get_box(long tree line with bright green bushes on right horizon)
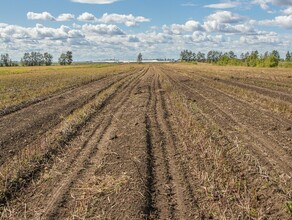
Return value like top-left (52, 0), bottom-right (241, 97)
top-left (180, 50), bottom-right (292, 67)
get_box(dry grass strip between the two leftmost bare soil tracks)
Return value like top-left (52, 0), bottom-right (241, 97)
top-left (0, 74), bottom-right (128, 206)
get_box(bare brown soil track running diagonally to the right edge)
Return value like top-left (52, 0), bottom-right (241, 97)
top-left (161, 66), bottom-right (292, 178)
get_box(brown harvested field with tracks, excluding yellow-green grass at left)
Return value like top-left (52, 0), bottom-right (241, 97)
top-left (0, 64), bottom-right (292, 219)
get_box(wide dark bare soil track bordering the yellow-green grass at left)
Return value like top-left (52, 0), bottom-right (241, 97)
top-left (0, 68), bottom-right (141, 165)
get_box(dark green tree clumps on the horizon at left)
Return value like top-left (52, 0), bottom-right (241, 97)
top-left (0, 51), bottom-right (73, 67)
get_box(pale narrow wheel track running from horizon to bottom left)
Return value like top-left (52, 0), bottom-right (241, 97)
top-left (40, 68), bottom-right (146, 219)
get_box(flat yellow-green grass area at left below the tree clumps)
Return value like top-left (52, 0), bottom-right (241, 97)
top-left (0, 65), bottom-right (135, 110)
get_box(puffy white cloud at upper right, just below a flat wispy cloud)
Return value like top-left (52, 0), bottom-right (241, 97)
top-left (206, 11), bottom-right (244, 24)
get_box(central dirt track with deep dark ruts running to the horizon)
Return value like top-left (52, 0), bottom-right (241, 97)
top-left (145, 68), bottom-right (196, 219)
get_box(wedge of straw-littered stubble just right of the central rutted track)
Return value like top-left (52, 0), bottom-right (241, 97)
top-left (164, 72), bottom-right (291, 219)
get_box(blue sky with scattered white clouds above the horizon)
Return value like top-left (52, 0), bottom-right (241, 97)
top-left (0, 0), bottom-right (292, 61)
